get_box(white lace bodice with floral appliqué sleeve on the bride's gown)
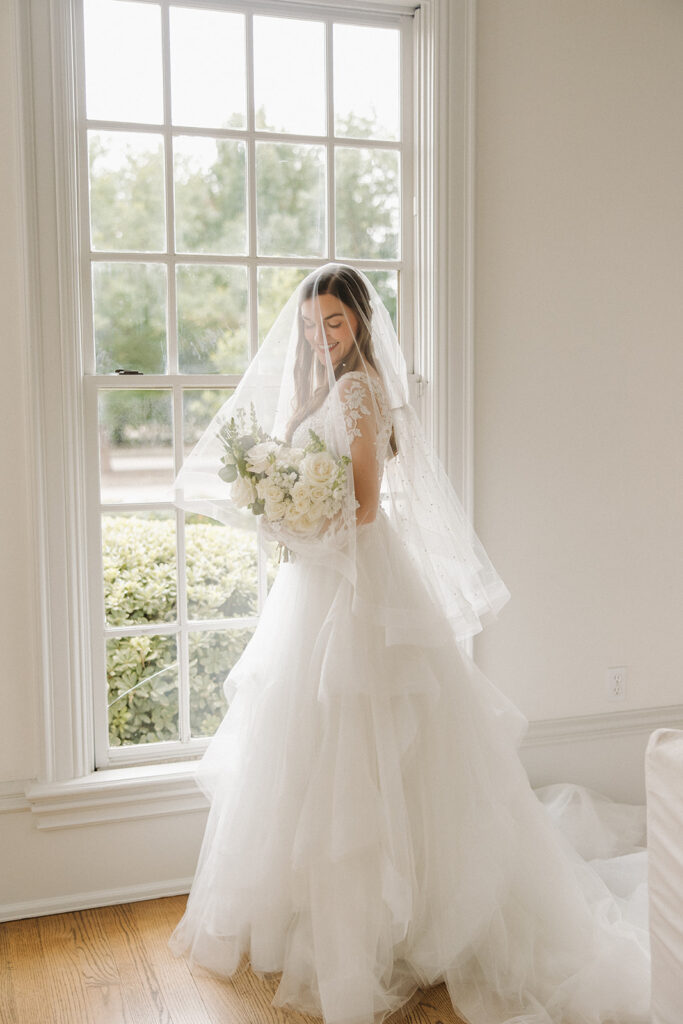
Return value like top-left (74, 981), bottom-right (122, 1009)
top-left (292, 370), bottom-right (391, 476)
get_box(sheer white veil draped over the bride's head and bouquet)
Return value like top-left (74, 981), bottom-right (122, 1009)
top-left (170, 263), bottom-right (510, 642)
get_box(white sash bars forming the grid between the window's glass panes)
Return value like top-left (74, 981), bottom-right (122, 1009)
top-left (74, 0), bottom-right (415, 769)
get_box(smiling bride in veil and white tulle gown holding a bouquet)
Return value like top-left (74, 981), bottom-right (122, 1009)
top-left (165, 263), bottom-right (649, 1024)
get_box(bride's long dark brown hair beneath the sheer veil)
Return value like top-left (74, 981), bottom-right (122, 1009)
top-left (286, 264), bottom-right (397, 455)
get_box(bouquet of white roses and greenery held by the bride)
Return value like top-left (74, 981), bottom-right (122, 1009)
top-left (218, 406), bottom-right (351, 537)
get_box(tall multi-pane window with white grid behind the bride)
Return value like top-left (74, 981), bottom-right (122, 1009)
top-left (79, 0), bottom-right (413, 767)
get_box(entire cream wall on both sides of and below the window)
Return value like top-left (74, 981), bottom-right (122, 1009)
top-left (0, 0), bottom-right (683, 915)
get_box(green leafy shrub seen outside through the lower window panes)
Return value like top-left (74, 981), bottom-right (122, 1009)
top-left (102, 513), bottom-right (264, 746)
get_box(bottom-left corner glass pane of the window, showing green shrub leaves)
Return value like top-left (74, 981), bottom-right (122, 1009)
top-left (106, 636), bottom-right (178, 746)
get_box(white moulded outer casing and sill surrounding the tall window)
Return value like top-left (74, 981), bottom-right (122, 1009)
top-left (13, 0), bottom-right (475, 828)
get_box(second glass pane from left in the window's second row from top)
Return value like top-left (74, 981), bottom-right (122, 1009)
top-left (173, 135), bottom-right (247, 255)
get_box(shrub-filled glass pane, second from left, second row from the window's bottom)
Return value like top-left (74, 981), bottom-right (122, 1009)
top-left (185, 514), bottom-right (258, 621)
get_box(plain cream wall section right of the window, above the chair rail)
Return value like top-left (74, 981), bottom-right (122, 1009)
top-left (475, 0), bottom-right (683, 720)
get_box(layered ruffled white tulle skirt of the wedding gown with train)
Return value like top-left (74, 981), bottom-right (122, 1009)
top-left (170, 514), bottom-right (649, 1024)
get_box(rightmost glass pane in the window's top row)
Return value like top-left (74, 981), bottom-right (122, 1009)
top-left (334, 25), bottom-right (400, 139)
